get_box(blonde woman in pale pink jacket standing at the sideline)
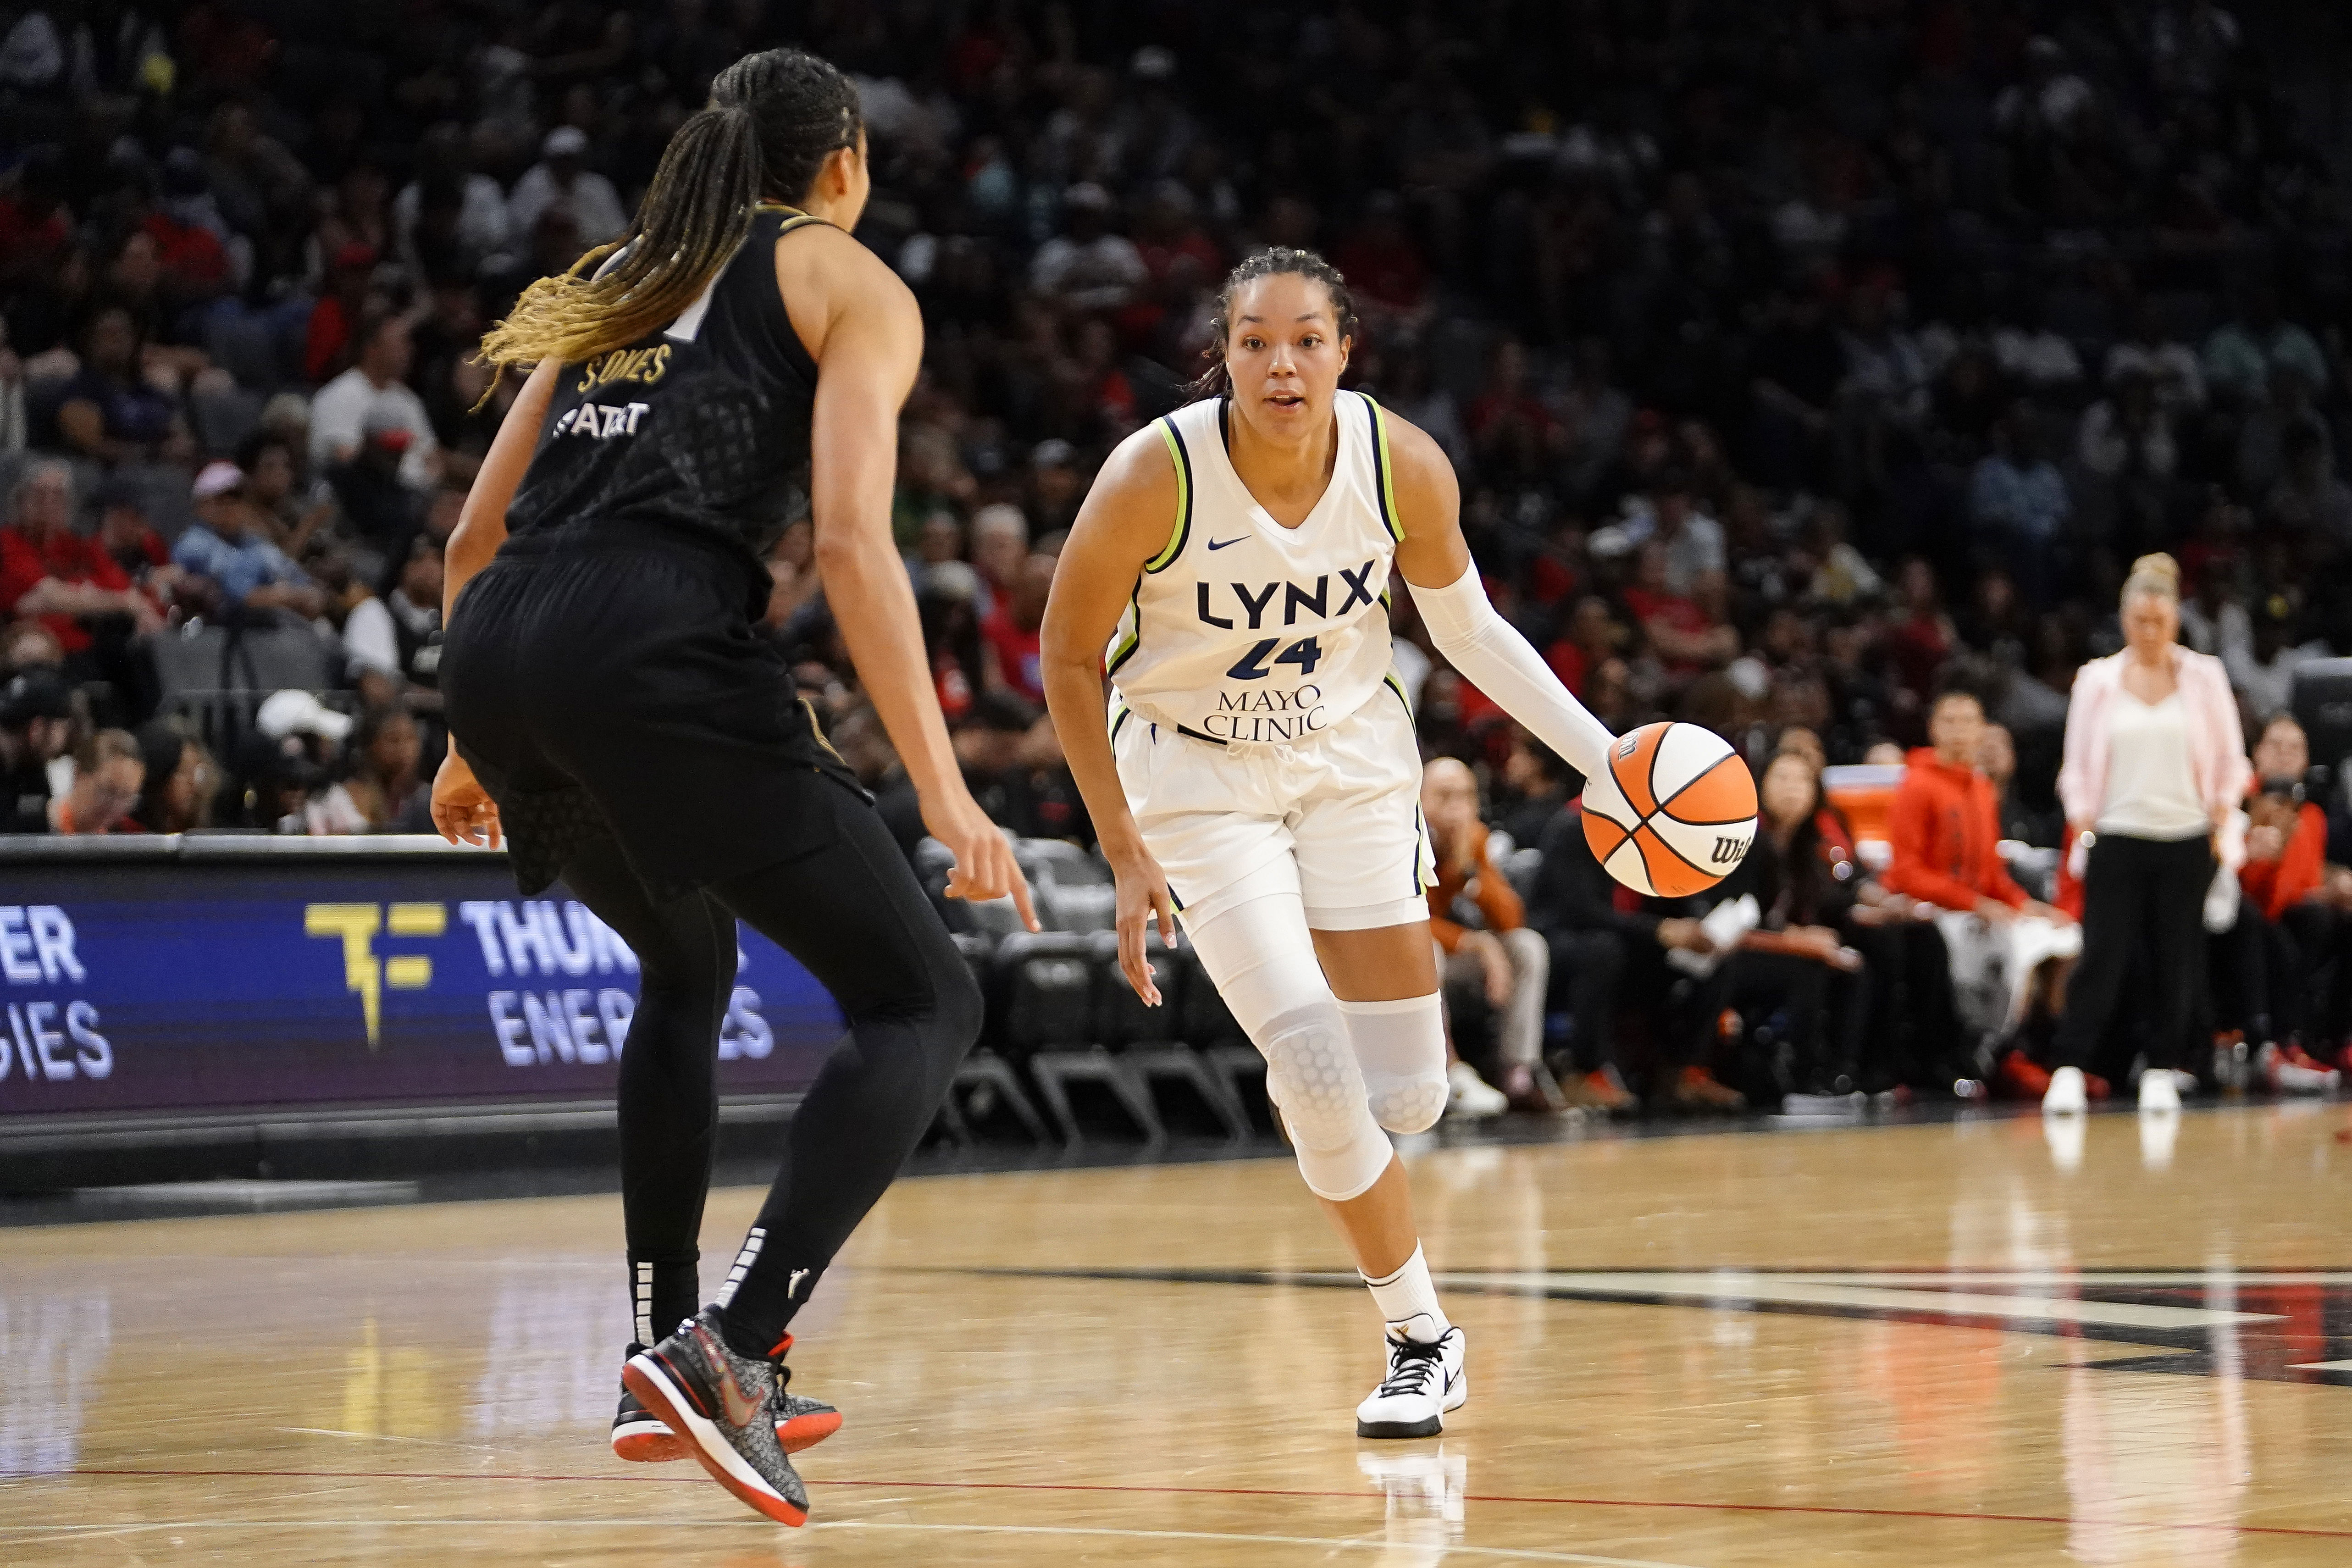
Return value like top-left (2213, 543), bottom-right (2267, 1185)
top-left (2042, 555), bottom-right (2251, 1112)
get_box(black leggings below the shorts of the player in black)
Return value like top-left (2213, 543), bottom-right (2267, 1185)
top-left (564, 787), bottom-right (981, 1357)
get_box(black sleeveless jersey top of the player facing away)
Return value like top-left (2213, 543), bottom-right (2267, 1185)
top-left (506, 202), bottom-right (823, 583)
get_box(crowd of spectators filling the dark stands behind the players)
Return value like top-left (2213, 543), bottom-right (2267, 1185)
top-left (0, 0), bottom-right (2352, 1105)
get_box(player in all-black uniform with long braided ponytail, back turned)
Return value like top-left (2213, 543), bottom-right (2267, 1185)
top-left (433, 50), bottom-right (1035, 1526)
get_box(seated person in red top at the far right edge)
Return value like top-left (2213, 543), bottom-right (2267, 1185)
top-left (2213, 712), bottom-right (2352, 1088)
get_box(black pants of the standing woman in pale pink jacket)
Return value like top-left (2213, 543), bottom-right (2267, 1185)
top-left (2056, 832), bottom-right (2213, 1067)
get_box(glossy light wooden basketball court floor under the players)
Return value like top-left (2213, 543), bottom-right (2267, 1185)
top-left (0, 1107), bottom-right (2352, 1568)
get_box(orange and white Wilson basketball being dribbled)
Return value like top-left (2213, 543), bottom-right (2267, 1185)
top-left (1585, 724), bottom-right (1757, 898)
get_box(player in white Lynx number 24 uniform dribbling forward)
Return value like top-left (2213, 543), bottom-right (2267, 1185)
top-left (1044, 249), bottom-right (1611, 1436)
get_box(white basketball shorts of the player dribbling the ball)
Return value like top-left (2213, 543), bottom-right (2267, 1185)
top-left (1110, 687), bottom-right (1437, 931)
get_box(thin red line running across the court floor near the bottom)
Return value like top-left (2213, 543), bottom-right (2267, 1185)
top-left (0, 1469), bottom-right (2352, 1540)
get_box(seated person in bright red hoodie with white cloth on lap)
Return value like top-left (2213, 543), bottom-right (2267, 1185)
top-left (1879, 689), bottom-right (2081, 1098)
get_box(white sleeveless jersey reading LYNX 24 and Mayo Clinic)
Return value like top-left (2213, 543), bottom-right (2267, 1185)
top-left (1106, 393), bottom-right (1404, 745)
